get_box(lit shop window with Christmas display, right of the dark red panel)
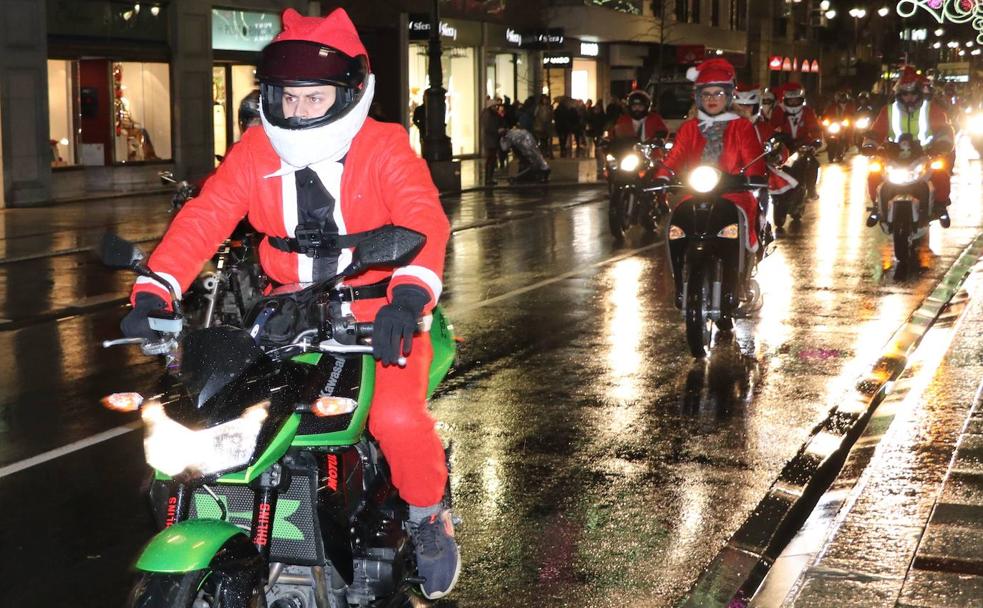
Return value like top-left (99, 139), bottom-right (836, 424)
top-left (112, 62), bottom-right (171, 163)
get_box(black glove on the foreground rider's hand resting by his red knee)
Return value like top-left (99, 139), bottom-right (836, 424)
top-left (372, 285), bottom-right (430, 365)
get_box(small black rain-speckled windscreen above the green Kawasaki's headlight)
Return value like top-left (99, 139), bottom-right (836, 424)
top-left (181, 327), bottom-right (266, 409)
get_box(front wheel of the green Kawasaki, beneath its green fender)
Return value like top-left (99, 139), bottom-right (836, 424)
top-left (126, 570), bottom-right (267, 608)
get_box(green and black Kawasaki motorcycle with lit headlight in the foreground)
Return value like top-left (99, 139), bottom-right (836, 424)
top-left (102, 226), bottom-right (455, 608)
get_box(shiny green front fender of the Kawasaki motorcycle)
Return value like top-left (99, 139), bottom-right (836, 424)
top-left (136, 519), bottom-right (261, 574)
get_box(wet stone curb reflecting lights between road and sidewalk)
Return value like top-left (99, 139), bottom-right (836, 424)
top-left (679, 233), bottom-right (983, 608)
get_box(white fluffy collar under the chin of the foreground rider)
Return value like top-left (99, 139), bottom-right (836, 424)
top-left (260, 74), bottom-right (375, 177)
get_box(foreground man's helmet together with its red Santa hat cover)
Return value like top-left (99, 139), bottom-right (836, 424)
top-left (256, 8), bottom-right (371, 129)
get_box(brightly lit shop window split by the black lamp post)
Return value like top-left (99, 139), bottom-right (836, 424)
top-left (409, 44), bottom-right (478, 155)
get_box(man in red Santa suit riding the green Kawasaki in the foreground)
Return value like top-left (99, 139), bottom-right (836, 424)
top-left (122, 9), bottom-right (460, 599)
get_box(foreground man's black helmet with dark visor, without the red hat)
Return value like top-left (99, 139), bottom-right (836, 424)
top-left (256, 40), bottom-right (369, 129)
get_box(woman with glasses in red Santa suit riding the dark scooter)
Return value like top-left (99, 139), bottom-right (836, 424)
top-left (656, 59), bottom-right (766, 251)
